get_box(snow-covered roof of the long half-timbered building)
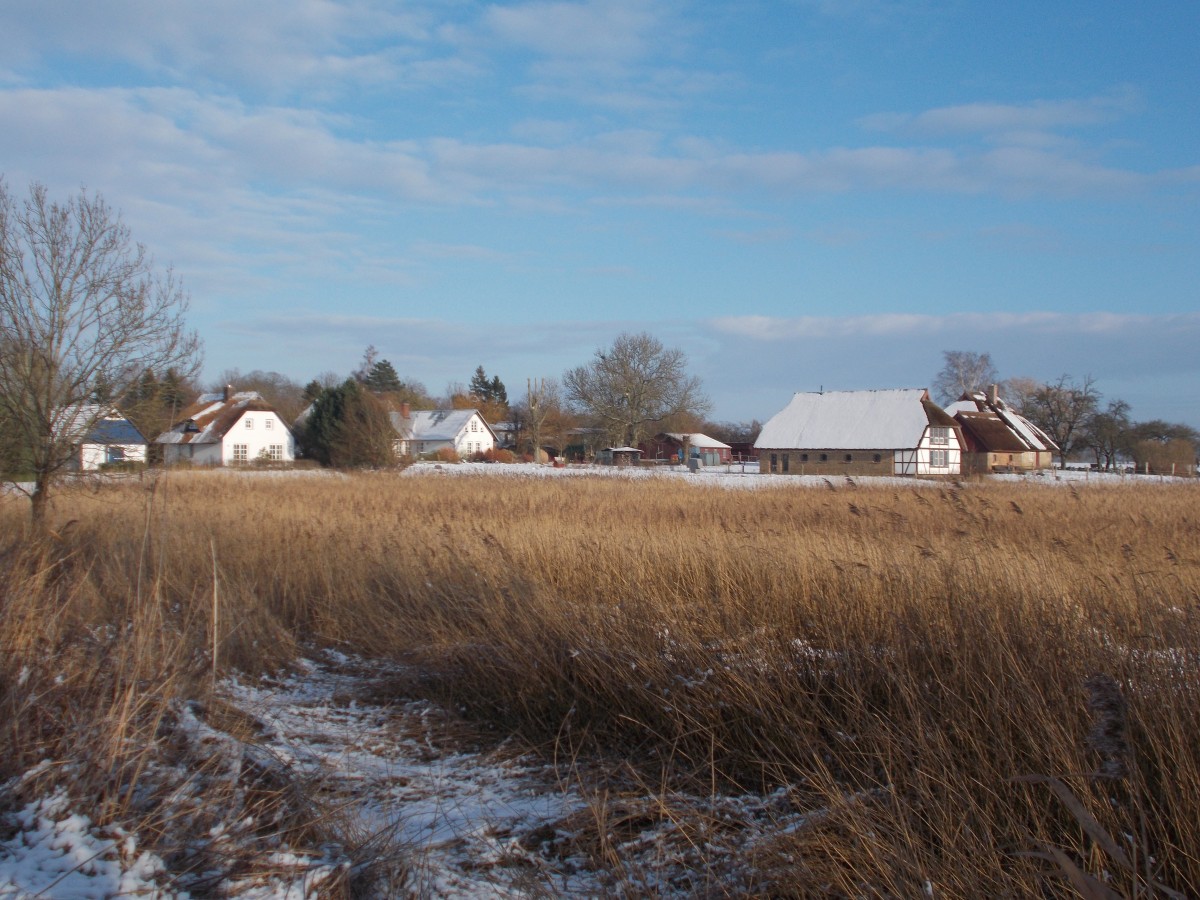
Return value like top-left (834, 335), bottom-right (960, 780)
top-left (755, 388), bottom-right (940, 450)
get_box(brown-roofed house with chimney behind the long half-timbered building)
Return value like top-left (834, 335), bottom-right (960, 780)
top-left (946, 384), bottom-right (1058, 473)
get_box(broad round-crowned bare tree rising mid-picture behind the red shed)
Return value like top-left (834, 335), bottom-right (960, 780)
top-left (563, 331), bottom-right (709, 446)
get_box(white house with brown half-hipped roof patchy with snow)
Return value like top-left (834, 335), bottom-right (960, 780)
top-left (155, 386), bottom-right (295, 466)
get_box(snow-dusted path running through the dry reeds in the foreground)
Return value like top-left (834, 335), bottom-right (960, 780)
top-left (228, 654), bottom-right (604, 898)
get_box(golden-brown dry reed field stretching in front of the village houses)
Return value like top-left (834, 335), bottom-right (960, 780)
top-left (0, 472), bottom-right (1200, 898)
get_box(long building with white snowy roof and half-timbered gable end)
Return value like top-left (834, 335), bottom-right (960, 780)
top-left (755, 388), bottom-right (962, 475)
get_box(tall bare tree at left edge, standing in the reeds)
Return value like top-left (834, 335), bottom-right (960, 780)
top-left (0, 179), bottom-right (199, 529)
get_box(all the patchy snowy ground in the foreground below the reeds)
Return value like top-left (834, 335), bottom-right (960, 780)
top-left (0, 653), bottom-right (820, 900)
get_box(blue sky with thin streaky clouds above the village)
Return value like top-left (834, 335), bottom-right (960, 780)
top-left (0, 0), bottom-right (1200, 426)
